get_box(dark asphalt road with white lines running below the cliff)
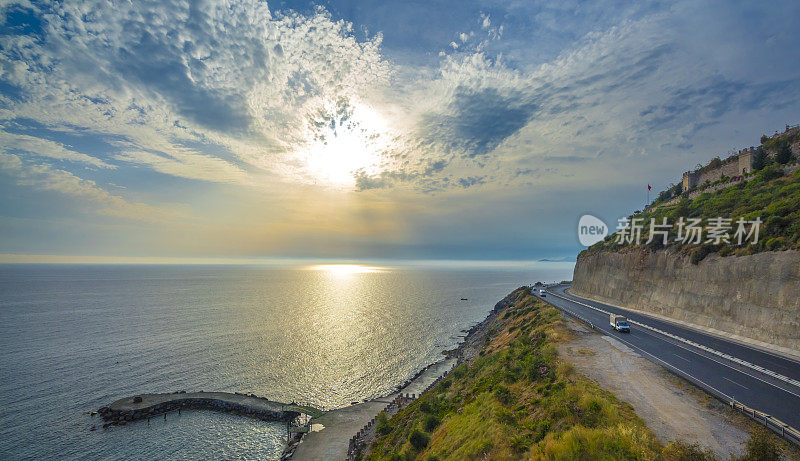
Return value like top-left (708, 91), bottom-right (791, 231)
top-left (537, 286), bottom-right (800, 429)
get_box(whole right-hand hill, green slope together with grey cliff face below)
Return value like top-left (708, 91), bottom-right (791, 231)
top-left (571, 127), bottom-right (800, 355)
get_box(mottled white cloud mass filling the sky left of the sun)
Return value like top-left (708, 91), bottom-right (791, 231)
top-left (0, 0), bottom-right (391, 184)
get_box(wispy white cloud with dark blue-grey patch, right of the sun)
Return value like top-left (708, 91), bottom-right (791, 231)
top-left (360, 3), bottom-right (800, 190)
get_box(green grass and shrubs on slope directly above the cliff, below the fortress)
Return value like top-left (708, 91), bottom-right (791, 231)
top-left (578, 165), bottom-right (800, 264)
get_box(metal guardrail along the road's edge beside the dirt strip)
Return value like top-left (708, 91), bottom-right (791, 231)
top-left (548, 292), bottom-right (800, 445)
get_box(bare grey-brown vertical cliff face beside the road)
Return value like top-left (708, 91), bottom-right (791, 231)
top-left (571, 250), bottom-right (800, 351)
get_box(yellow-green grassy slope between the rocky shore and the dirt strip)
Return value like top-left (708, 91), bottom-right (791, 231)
top-left (362, 288), bottom-right (780, 460)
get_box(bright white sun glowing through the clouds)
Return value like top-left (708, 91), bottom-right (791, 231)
top-left (304, 104), bottom-right (387, 186)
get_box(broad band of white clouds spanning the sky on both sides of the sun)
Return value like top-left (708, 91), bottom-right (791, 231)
top-left (0, 0), bottom-right (797, 198)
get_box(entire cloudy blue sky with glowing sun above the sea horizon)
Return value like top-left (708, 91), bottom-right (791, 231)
top-left (0, 0), bottom-right (800, 261)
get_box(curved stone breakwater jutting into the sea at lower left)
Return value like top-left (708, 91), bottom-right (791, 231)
top-left (97, 392), bottom-right (300, 428)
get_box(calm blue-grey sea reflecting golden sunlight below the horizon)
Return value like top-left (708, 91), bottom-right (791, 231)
top-left (0, 263), bottom-right (572, 459)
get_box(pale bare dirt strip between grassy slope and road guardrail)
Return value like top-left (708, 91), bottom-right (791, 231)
top-left (559, 320), bottom-right (749, 459)
